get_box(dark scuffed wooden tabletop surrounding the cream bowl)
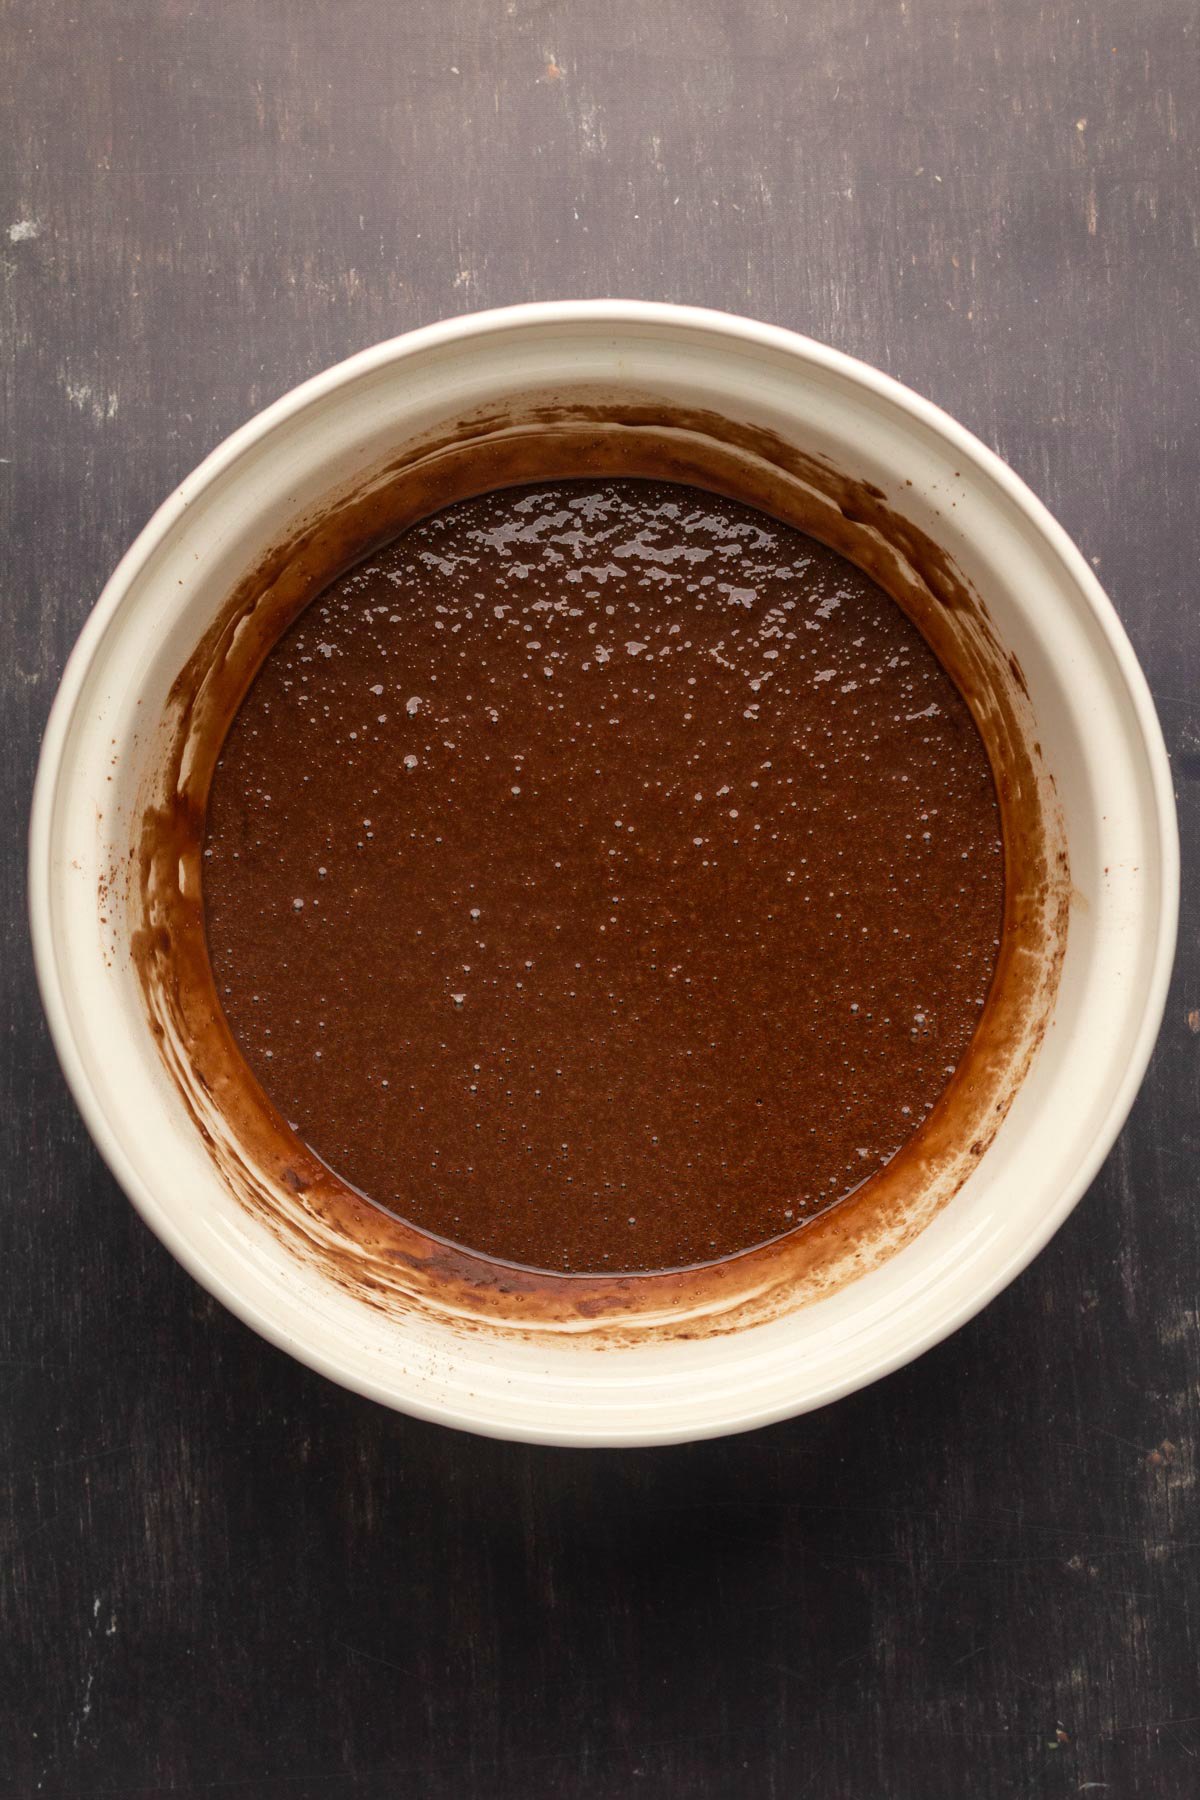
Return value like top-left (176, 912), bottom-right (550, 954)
top-left (0, 0), bottom-right (1200, 1800)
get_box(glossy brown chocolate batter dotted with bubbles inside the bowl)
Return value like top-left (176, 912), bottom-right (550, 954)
top-left (203, 481), bottom-right (1004, 1273)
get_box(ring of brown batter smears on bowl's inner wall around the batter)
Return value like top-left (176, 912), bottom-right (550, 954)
top-left (130, 394), bottom-right (1070, 1345)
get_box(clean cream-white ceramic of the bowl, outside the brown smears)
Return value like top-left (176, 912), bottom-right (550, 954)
top-left (31, 301), bottom-right (1178, 1444)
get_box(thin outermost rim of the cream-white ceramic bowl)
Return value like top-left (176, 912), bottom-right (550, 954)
top-left (29, 299), bottom-right (1180, 1445)
